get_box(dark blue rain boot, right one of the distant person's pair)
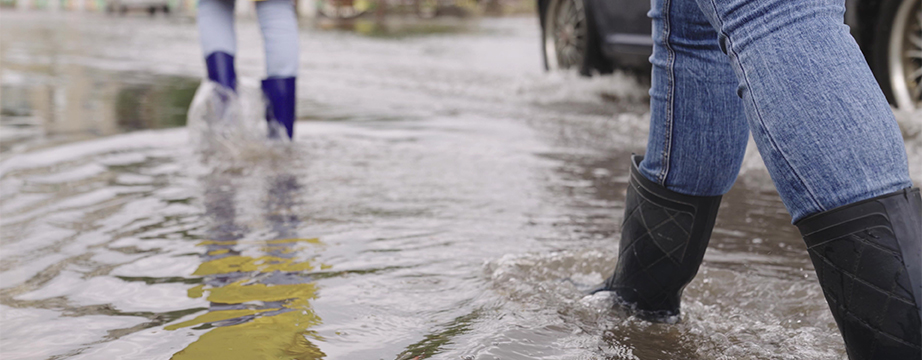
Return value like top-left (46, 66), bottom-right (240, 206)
top-left (262, 76), bottom-right (297, 139)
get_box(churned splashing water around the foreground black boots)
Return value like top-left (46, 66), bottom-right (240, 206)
top-left (484, 251), bottom-right (844, 360)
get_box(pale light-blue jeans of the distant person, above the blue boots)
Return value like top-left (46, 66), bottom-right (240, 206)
top-left (198, 0), bottom-right (298, 78)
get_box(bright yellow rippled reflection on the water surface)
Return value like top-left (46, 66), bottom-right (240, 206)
top-left (165, 239), bottom-right (329, 360)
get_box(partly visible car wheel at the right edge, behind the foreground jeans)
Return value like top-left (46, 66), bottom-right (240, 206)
top-left (873, 0), bottom-right (922, 111)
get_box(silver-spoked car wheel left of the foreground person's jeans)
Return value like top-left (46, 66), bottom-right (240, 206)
top-left (542, 0), bottom-right (612, 75)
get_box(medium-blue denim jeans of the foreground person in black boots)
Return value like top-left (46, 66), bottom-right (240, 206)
top-left (640, 0), bottom-right (912, 222)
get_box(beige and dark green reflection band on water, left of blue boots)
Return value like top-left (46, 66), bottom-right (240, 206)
top-left (0, 58), bottom-right (199, 152)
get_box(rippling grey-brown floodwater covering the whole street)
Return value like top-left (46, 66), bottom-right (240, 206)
top-left (0, 11), bottom-right (922, 360)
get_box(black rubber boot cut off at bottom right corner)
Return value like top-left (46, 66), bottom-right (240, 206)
top-left (796, 189), bottom-right (922, 360)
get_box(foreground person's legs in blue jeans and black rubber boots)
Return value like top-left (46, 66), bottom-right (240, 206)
top-left (604, 0), bottom-right (922, 359)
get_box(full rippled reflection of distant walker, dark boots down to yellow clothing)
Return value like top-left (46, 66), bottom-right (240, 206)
top-left (166, 174), bottom-right (325, 360)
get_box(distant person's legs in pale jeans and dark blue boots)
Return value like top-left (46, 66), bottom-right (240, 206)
top-left (198, 0), bottom-right (299, 137)
